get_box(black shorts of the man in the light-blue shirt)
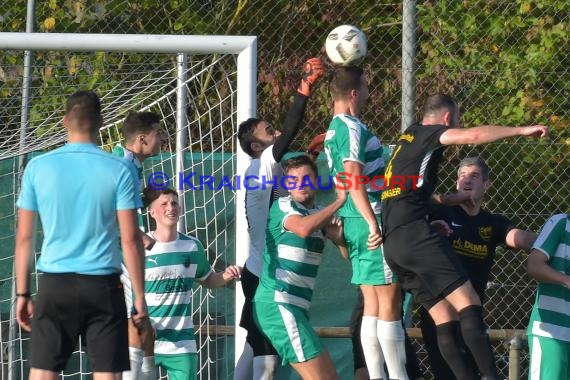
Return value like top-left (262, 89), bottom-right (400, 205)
top-left (30, 273), bottom-right (130, 372)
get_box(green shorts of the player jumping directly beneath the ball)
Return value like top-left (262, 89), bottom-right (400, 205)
top-left (342, 215), bottom-right (396, 285)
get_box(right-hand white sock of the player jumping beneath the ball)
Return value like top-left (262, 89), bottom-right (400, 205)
top-left (377, 320), bottom-right (408, 380)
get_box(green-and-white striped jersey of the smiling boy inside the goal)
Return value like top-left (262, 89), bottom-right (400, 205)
top-left (144, 233), bottom-right (212, 355)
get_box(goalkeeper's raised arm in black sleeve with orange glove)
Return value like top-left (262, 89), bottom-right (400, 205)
top-left (273, 58), bottom-right (325, 162)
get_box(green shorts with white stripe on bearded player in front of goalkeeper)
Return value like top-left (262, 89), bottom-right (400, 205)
top-left (253, 302), bottom-right (323, 365)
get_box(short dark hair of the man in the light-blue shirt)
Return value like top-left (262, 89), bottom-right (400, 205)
top-left (65, 90), bottom-right (103, 132)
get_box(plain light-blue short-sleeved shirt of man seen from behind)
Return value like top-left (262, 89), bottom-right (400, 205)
top-left (17, 143), bottom-right (141, 275)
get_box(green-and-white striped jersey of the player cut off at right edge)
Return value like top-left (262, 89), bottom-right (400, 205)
top-left (527, 214), bottom-right (570, 342)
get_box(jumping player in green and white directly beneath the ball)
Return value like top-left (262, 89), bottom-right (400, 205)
top-left (325, 66), bottom-right (408, 380)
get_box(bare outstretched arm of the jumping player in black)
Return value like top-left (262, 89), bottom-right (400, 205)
top-left (439, 125), bottom-right (549, 145)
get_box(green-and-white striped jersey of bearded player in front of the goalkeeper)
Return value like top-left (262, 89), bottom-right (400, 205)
top-left (254, 196), bottom-right (325, 310)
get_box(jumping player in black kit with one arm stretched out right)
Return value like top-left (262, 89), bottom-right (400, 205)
top-left (382, 94), bottom-right (548, 380)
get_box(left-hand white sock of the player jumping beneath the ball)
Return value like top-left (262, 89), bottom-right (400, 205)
top-left (360, 315), bottom-right (387, 379)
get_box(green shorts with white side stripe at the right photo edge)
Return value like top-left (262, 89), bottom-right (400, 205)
top-left (528, 335), bottom-right (570, 380)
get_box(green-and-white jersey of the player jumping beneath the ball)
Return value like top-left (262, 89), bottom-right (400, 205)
top-left (324, 114), bottom-right (385, 217)
